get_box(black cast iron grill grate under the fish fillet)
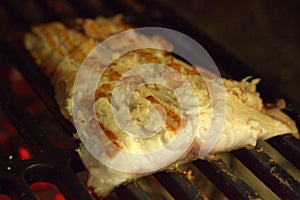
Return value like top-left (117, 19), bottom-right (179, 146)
top-left (0, 0), bottom-right (300, 199)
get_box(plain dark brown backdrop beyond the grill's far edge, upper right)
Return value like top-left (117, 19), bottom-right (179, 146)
top-left (160, 0), bottom-right (300, 105)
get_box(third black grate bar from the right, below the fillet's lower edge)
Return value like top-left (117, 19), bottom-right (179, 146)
top-left (193, 156), bottom-right (262, 199)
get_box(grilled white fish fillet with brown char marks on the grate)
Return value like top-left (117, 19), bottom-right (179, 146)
top-left (24, 15), bottom-right (299, 197)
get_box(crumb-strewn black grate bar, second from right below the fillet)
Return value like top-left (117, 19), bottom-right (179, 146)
top-left (233, 147), bottom-right (300, 199)
